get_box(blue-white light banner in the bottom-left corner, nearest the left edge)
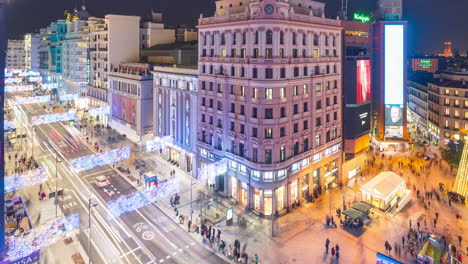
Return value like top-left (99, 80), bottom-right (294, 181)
top-left (6, 214), bottom-right (80, 263)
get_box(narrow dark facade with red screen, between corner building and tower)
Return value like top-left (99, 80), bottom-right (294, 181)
top-left (342, 19), bottom-right (372, 185)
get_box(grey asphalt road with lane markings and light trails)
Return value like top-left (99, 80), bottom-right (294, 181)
top-left (11, 99), bottom-right (227, 264)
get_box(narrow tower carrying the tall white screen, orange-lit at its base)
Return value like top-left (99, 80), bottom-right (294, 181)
top-left (372, 0), bottom-right (408, 151)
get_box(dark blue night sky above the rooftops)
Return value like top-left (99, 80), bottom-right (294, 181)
top-left (3, 0), bottom-right (468, 54)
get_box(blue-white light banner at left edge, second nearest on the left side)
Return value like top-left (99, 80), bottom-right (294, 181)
top-left (5, 167), bottom-right (49, 193)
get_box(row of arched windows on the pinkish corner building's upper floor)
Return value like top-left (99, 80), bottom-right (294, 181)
top-left (203, 30), bottom-right (337, 47)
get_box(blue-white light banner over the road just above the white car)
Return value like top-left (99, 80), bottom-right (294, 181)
top-left (70, 146), bottom-right (130, 172)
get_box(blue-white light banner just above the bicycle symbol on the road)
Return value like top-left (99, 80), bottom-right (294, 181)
top-left (107, 179), bottom-right (179, 220)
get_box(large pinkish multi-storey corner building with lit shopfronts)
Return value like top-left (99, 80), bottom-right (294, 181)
top-left (197, 0), bottom-right (342, 215)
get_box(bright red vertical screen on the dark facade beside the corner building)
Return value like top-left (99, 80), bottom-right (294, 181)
top-left (356, 60), bottom-right (371, 104)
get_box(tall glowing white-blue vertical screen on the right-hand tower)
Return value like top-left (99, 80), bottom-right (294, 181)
top-left (384, 25), bottom-right (405, 105)
